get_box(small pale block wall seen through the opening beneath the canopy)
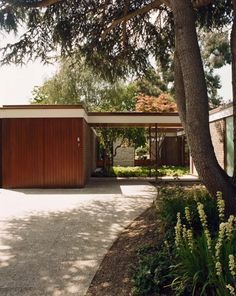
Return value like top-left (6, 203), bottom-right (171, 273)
top-left (113, 140), bottom-right (135, 166)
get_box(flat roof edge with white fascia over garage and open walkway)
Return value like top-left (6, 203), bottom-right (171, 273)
top-left (0, 105), bottom-right (182, 130)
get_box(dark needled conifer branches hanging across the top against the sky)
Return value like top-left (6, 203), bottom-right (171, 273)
top-left (0, 0), bottom-right (232, 77)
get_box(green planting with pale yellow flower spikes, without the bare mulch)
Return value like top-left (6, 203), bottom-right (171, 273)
top-left (133, 187), bottom-right (236, 296)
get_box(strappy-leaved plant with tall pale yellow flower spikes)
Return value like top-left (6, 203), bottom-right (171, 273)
top-left (172, 194), bottom-right (236, 296)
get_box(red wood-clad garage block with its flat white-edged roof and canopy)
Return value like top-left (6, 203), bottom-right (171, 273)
top-left (0, 105), bottom-right (182, 188)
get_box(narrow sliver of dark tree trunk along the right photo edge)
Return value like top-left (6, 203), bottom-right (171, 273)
top-left (230, 0), bottom-right (236, 178)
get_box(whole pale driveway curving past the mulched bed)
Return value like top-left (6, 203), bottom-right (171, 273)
top-left (0, 180), bottom-right (156, 296)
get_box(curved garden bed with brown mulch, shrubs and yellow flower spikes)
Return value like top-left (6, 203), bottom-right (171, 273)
top-left (86, 186), bottom-right (236, 296)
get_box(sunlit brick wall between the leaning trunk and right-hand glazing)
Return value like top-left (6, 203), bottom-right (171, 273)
top-left (210, 119), bottom-right (225, 169)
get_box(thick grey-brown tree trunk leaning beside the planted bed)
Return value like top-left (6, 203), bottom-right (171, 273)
top-left (170, 0), bottom-right (236, 214)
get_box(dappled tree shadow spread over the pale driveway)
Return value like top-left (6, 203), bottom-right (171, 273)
top-left (0, 180), bottom-right (154, 296)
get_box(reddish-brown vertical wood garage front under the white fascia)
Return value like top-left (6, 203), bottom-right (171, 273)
top-left (2, 118), bottom-right (84, 188)
